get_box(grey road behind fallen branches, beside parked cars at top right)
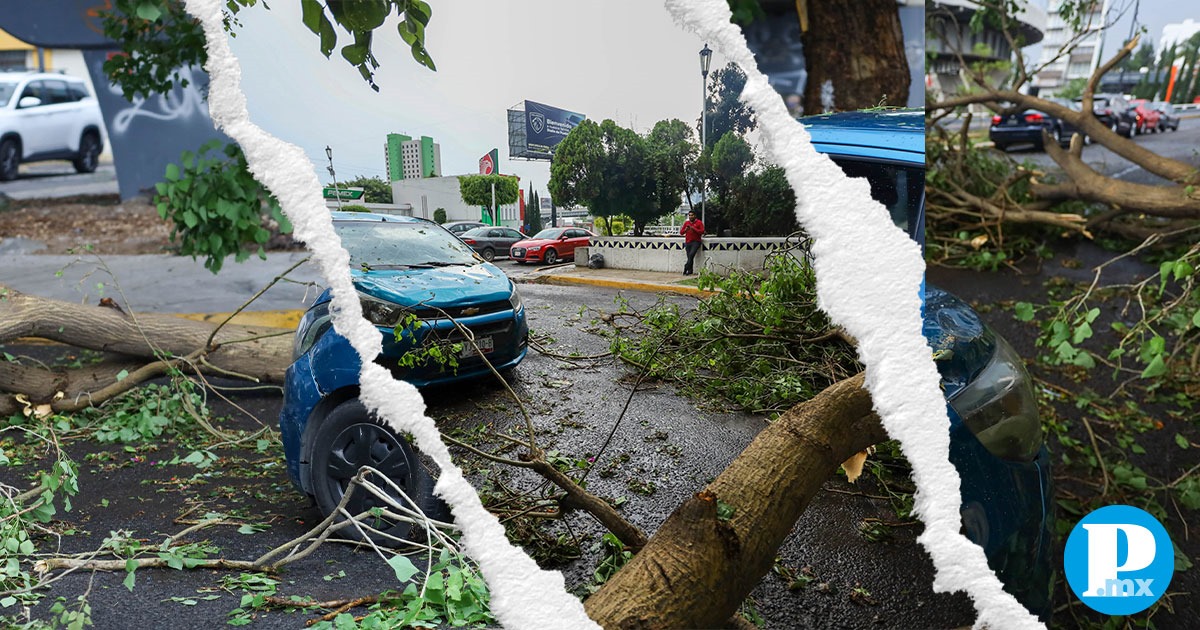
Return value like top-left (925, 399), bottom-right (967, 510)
top-left (1009, 118), bottom-right (1200, 185)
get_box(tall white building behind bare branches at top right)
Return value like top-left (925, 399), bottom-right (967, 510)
top-left (1033, 0), bottom-right (1114, 96)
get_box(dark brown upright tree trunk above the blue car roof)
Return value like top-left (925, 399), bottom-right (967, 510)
top-left (800, 0), bottom-right (911, 114)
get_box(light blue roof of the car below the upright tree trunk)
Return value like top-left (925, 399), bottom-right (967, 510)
top-left (798, 109), bottom-right (925, 166)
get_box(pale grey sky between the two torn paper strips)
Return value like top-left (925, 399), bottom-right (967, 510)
top-left (232, 0), bottom-right (725, 192)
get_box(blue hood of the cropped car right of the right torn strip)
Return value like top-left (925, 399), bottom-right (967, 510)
top-left (922, 286), bottom-right (996, 398)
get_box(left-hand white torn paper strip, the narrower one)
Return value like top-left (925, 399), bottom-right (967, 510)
top-left (186, 0), bottom-right (600, 629)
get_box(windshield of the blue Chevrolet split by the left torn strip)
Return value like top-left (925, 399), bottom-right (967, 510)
top-left (334, 221), bottom-right (479, 269)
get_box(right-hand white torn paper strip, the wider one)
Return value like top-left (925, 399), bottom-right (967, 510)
top-left (666, 0), bottom-right (1042, 628)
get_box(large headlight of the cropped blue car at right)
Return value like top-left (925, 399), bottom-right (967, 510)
top-left (949, 335), bottom-right (1042, 462)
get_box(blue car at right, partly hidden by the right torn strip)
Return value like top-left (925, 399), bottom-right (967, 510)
top-left (800, 110), bottom-right (1056, 619)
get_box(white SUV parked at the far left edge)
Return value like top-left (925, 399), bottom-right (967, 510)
top-left (0, 72), bottom-right (103, 181)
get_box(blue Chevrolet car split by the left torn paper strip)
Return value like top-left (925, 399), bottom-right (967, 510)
top-left (280, 212), bottom-right (529, 538)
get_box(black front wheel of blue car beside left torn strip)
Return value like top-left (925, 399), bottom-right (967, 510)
top-left (311, 398), bottom-right (451, 545)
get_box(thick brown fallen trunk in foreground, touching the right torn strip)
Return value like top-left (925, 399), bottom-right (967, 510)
top-left (584, 374), bottom-right (887, 628)
